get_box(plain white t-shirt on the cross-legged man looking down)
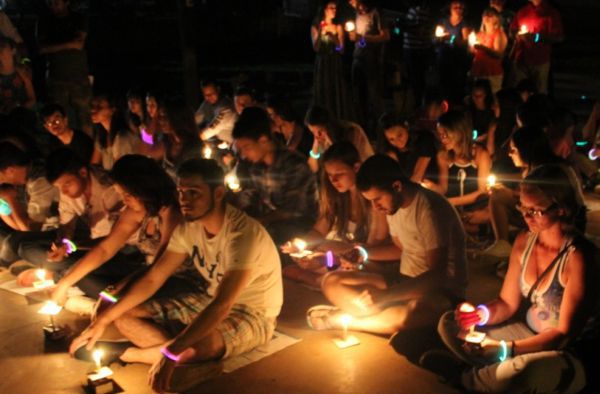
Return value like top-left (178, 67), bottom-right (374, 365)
top-left (387, 188), bottom-right (467, 291)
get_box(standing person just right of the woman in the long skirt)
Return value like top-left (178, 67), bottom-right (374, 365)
top-left (349, 0), bottom-right (390, 137)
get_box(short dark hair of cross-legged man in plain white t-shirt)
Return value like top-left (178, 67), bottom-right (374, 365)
top-left (356, 154), bottom-right (410, 192)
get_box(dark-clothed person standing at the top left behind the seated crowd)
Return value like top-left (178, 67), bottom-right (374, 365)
top-left (36, 0), bottom-right (92, 135)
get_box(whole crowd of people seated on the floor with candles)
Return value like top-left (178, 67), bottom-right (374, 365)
top-left (0, 75), bottom-right (600, 392)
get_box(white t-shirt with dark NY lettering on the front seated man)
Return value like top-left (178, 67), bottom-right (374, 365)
top-left (167, 205), bottom-right (283, 317)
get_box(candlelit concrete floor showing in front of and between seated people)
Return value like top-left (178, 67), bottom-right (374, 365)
top-left (0, 203), bottom-right (600, 394)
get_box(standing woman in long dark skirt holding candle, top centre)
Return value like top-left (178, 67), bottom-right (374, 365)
top-left (310, 1), bottom-right (353, 119)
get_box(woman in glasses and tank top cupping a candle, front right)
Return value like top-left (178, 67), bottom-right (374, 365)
top-left (421, 165), bottom-right (600, 393)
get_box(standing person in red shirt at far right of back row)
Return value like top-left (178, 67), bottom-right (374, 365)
top-left (510, 0), bottom-right (564, 94)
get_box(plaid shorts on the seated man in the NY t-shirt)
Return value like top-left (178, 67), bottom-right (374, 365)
top-left (144, 293), bottom-right (276, 358)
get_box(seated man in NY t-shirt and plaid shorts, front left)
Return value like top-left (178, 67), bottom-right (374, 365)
top-left (71, 159), bottom-right (283, 392)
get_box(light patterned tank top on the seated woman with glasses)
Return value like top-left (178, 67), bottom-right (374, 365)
top-left (519, 233), bottom-right (575, 332)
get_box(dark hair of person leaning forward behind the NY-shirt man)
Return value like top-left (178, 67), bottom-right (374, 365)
top-left (109, 155), bottom-right (178, 216)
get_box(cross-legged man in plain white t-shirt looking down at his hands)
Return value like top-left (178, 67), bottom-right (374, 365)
top-left (308, 155), bottom-right (466, 334)
